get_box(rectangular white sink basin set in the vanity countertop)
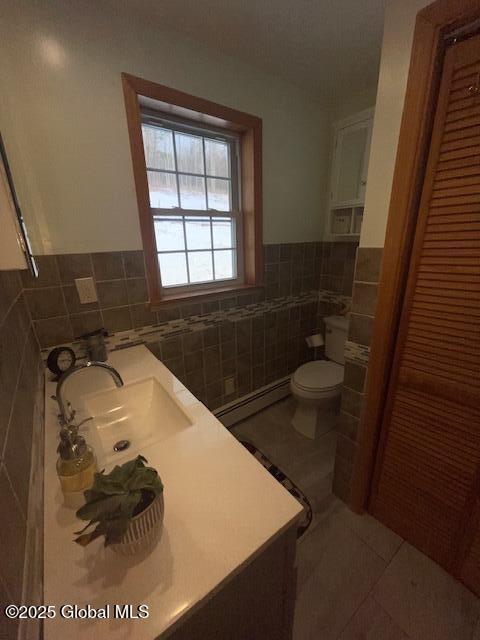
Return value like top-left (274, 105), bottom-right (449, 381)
top-left (83, 377), bottom-right (192, 464)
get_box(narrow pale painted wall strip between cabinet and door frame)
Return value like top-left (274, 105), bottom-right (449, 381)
top-left (360, 0), bottom-right (430, 247)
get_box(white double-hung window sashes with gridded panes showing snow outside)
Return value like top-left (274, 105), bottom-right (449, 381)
top-left (142, 118), bottom-right (242, 289)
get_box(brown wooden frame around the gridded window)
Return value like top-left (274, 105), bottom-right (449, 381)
top-left (122, 73), bottom-right (263, 308)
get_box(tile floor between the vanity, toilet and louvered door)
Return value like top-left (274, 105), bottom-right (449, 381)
top-left (232, 398), bottom-right (480, 640)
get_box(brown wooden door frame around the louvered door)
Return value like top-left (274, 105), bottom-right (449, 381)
top-left (349, 0), bottom-right (480, 513)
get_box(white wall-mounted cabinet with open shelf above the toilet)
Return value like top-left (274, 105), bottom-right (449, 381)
top-left (325, 109), bottom-right (373, 238)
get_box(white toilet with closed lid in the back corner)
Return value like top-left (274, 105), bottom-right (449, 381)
top-left (290, 316), bottom-right (348, 440)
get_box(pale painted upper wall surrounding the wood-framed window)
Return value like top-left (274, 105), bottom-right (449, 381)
top-left (0, 0), bottom-right (329, 253)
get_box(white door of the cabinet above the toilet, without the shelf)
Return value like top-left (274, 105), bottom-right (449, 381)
top-left (332, 119), bottom-right (372, 206)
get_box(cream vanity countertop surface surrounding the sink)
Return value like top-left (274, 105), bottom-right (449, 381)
top-left (44, 346), bottom-right (301, 640)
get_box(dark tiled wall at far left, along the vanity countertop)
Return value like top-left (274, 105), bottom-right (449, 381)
top-left (0, 271), bottom-right (43, 638)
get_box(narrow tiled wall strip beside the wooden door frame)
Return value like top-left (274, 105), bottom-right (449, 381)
top-left (333, 247), bottom-right (383, 502)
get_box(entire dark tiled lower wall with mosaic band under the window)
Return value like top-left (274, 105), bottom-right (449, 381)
top-left (24, 242), bottom-right (356, 409)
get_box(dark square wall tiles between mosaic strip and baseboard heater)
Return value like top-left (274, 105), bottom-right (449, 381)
top-left (147, 294), bottom-right (342, 409)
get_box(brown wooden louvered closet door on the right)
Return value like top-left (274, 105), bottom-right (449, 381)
top-left (369, 32), bottom-right (480, 593)
